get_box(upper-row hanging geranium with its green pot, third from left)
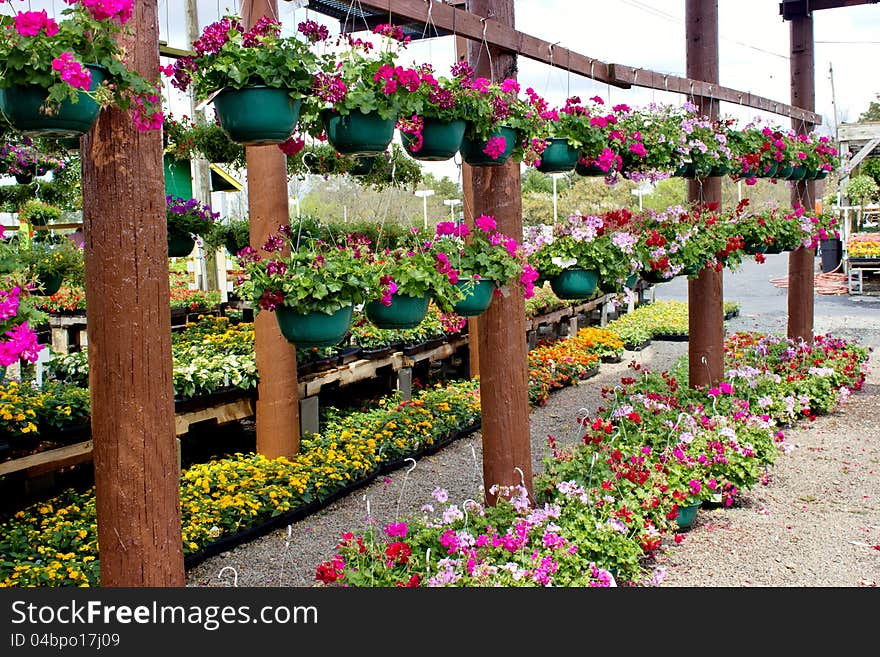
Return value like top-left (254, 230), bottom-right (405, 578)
top-left (305, 25), bottom-right (422, 155)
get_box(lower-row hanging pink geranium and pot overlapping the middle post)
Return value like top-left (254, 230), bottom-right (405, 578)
top-left (434, 215), bottom-right (537, 317)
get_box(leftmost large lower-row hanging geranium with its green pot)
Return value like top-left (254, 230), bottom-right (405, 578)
top-left (238, 227), bottom-right (376, 348)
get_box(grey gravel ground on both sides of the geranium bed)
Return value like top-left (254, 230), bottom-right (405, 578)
top-left (187, 259), bottom-right (880, 587)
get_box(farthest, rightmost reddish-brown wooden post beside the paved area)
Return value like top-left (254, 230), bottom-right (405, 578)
top-left (788, 14), bottom-right (816, 342)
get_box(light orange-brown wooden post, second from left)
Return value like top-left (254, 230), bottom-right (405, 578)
top-left (242, 0), bottom-right (299, 458)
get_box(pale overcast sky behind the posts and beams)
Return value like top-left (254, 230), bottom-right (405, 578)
top-left (0, 0), bottom-right (880, 184)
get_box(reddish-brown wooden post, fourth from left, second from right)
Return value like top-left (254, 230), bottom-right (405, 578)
top-left (685, 0), bottom-right (724, 388)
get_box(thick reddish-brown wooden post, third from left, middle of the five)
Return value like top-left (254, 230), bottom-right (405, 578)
top-left (468, 0), bottom-right (532, 504)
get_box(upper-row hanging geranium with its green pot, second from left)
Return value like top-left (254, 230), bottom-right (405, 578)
top-left (171, 16), bottom-right (316, 144)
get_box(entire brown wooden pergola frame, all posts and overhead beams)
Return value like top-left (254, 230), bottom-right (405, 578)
top-left (82, 0), bottom-right (877, 586)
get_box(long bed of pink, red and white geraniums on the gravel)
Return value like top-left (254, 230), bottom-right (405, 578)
top-left (316, 334), bottom-right (867, 586)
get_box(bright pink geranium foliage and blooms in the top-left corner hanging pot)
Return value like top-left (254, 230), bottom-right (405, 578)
top-left (0, 0), bottom-right (162, 130)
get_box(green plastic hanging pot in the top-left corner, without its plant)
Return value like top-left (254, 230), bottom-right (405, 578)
top-left (0, 64), bottom-right (107, 137)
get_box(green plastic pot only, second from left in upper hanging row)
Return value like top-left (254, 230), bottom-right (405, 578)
top-left (214, 85), bottom-right (302, 146)
